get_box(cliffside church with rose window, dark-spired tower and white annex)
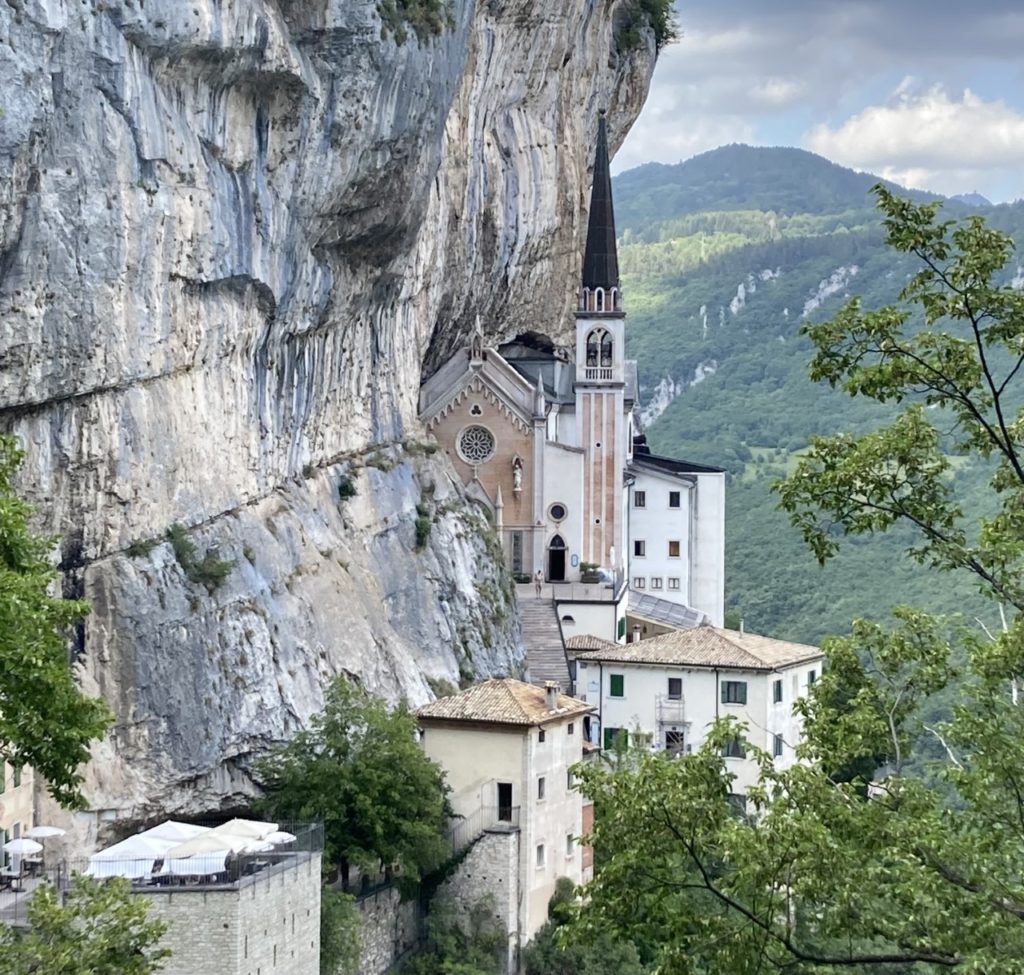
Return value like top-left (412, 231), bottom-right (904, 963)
top-left (420, 117), bottom-right (724, 638)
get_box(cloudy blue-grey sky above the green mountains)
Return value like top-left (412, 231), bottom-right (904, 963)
top-left (614, 0), bottom-right (1024, 203)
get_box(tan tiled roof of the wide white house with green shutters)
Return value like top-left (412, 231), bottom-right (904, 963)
top-left (577, 627), bottom-right (822, 670)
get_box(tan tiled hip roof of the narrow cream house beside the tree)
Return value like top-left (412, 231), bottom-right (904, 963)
top-left (416, 677), bottom-right (594, 725)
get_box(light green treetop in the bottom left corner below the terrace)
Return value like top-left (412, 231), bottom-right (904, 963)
top-left (0, 876), bottom-right (171, 975)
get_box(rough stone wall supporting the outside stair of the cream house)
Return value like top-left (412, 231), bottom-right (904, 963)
top-left (438, 828), bottom-right (520, 972)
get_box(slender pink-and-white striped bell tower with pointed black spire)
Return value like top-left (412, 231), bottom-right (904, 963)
top-left (575, 112), bottom-right (628, 571)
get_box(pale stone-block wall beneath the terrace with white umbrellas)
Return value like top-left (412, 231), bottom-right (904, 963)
top-left (141, 853), bottom-right (321, 975)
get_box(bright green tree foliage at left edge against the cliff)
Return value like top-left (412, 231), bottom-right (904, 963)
top-left (0, 436), bottom-right (113, 807)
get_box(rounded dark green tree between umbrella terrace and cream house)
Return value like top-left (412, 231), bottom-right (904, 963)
top-left (256, 676), bottom-right (449, 886)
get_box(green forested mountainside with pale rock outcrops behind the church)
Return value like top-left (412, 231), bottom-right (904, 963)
top-left (615, 145), bottom-right (1024, 640)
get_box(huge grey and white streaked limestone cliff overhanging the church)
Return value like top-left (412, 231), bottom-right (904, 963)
top-left (0, 0), bottom-right (653, 831)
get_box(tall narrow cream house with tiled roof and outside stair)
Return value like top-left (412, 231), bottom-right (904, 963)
top-left (417, 679), bottom-right (593, 947)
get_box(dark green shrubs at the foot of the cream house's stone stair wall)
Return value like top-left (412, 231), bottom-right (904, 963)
top-left (401, 896), bottom-right (506, 975)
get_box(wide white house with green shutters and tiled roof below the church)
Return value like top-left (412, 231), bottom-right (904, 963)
top-left (569, 626), bottom-right (822, 795)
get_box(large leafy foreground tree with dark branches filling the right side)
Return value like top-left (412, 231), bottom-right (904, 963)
top-left (574, 187), bottom-right (1024, 975)
